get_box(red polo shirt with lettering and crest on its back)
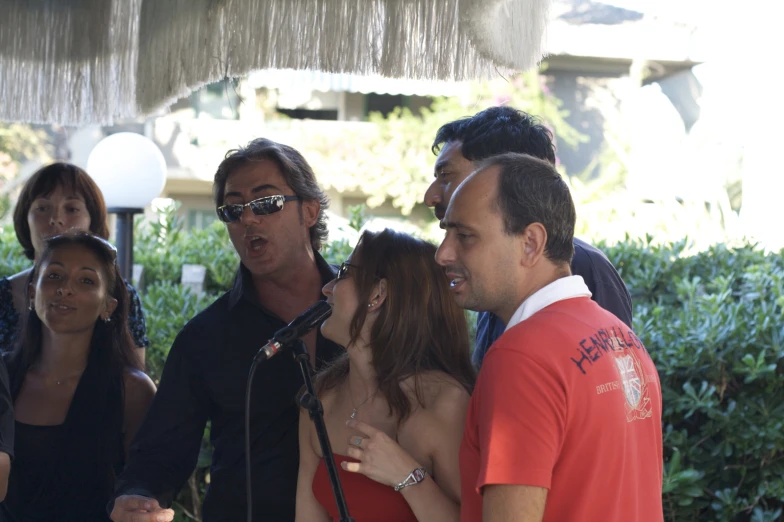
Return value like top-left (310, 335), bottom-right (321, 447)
top-left (460, 296), bottom-right (663, 522)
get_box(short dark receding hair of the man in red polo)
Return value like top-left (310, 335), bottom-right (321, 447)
top-left (477, 152), bottom-right (577, 264)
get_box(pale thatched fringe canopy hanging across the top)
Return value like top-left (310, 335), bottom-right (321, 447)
top-left (0, 0), bottom-right (550, 125)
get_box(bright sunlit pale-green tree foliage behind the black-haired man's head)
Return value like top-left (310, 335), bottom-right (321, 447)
top-left (306, 72), bottom-right (585, 215)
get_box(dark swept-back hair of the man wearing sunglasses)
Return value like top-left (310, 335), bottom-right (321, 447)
top-left (212, 138), bottom-right (329, 250)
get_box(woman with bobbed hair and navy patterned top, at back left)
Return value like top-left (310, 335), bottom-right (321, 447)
top-left (0, 163), bottom-right (150, 361)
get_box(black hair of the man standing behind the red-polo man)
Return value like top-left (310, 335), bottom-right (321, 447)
top-left (431, 107), bottom-right (555, 165)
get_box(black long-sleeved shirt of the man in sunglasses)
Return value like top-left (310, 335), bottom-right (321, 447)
top-left (109, 253), bottom-right (341, 522)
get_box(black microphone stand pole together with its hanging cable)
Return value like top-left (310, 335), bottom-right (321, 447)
top-left (245, 339), bottom-right (354, 522)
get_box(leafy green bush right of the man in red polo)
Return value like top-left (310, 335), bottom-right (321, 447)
top-left (604, 238), bottom-right (784, 522)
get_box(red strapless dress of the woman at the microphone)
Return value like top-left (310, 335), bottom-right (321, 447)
top-left (313, 455), bottom-right (417, 522)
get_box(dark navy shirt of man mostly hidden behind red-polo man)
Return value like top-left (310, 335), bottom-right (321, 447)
top-left (471, 238), bottom-right (632, 368)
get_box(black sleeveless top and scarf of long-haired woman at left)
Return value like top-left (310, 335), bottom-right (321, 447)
top-left (0, 348), bottom-right (125, 522)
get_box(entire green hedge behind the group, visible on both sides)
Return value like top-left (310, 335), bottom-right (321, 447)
top-left (0, 219), bottom-right (784, 522)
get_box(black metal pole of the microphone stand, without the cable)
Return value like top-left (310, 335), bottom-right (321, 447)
top-left (291, 339), bottom-right (354, 522)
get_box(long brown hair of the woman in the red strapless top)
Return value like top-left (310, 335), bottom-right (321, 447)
top-left (316, 229), bottom-right (475, 421)
